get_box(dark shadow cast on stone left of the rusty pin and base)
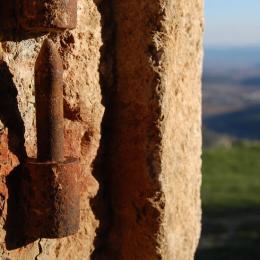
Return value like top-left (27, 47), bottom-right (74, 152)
top-left (0, 61), bottom-right (37, 250)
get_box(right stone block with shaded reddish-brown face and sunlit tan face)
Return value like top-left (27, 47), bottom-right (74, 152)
top-left (102, 0), bottom-right (203, 260)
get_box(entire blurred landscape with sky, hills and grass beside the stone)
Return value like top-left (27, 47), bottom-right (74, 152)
top-left (196, 0), bottom-right (260, 260)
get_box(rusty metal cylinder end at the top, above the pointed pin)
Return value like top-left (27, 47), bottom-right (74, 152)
top-left (17, 0), bottom-right (77, 32)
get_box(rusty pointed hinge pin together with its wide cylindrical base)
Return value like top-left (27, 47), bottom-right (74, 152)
top-left (22, 39), bottom-right (81, 239)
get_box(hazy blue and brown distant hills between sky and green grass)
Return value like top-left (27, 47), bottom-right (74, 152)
top-left (203, 47), bottom-right (260, 147)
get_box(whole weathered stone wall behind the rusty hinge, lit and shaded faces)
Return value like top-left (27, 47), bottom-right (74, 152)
top-left (0, 0), bottom-right (203, 260)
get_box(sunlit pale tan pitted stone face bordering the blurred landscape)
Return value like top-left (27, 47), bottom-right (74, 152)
top-left (161, 0), bottom-right (204, 260)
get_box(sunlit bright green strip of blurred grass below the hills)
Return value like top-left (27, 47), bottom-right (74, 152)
top-left (202, 143), bottom-right (260, 210)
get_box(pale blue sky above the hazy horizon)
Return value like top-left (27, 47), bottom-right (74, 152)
top-left (205, 0), bottom-right (260, 47)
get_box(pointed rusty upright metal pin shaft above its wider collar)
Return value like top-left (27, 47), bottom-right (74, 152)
top-left (35, 39), bottom-right (64, 162)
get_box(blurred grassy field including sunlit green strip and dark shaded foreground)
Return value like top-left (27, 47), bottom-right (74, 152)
top-left (196, 142), bottom-right (260, 260)
